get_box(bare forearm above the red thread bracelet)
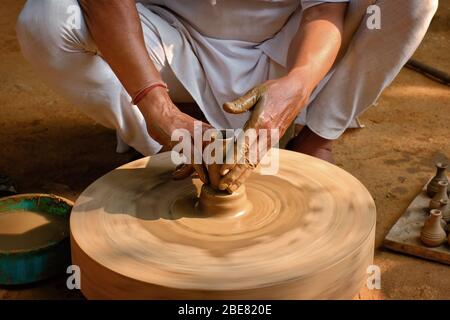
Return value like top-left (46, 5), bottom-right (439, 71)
top-left (80, 0), bottom-right (161, 95)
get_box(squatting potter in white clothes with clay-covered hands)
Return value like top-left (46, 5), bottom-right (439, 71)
top-left (17, 0), bottom-right (438, 185)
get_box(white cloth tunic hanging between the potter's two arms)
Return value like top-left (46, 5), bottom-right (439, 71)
top-left (137, 0), bottom-right (349, 129)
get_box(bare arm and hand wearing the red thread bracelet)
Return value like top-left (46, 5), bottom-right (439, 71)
top-left (80, 0), bottom-right (208, 181)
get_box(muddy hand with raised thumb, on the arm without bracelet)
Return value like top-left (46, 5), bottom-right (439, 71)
top-left (219, 75), bottom-right (311, 193)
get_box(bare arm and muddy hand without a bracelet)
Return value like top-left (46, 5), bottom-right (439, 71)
top-left (219, 3), bottom-right (347, 192)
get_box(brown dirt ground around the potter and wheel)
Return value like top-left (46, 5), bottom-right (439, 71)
top-left (0, 0), bottom-right (450, 299)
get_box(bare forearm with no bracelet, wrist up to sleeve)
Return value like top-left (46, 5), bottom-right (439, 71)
top-left (288, 3), bottom-right (347, 94)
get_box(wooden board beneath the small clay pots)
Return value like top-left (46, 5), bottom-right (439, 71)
top-left (384, 180), bottom-right (450, 265)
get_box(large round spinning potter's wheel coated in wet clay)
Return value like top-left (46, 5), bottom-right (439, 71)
top-left (70, 150), bottom-right (375, 299)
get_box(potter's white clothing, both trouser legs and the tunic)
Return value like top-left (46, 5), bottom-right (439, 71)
top-left (17, 0), bottom-right (438, 155)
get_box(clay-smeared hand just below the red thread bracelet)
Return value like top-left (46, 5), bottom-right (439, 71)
top-left (139, 88), bottom-right (212, 183)
